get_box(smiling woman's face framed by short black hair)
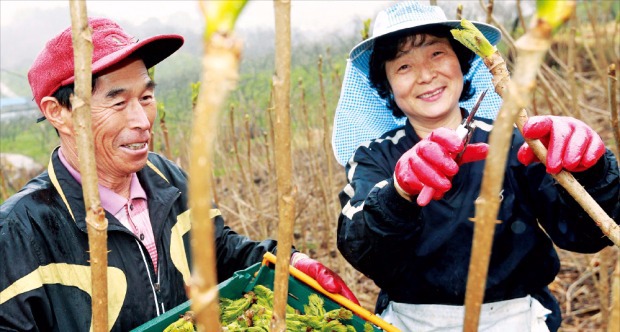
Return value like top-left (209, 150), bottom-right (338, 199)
top-left (385, 35), bottom-right (463, 123)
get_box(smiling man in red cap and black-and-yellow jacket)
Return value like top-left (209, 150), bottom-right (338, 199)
top-left (0, 18), bottom-right (357, 331)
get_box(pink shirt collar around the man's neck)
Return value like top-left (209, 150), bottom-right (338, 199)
top-left (58, 148), bottom-right (146, 215)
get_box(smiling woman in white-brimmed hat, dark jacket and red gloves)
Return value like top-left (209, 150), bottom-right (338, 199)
top-left (337, 1), bottom-right (620, 332)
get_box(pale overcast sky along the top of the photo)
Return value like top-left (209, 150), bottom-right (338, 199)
top-left (0, 0), bottom-right (532, 98)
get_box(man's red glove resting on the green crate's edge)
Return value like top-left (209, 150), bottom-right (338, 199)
top-left (291, 252), bottom-right (360, 305)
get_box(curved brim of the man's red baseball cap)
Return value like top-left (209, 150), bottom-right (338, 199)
top-left (61, 35), bottom-right (183, 86)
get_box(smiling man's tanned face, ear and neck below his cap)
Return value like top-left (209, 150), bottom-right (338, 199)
top-left (48, 58), bottom-right (157, 197)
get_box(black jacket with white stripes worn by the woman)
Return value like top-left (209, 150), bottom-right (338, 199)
top-left (338, 119), bottom-right (620, 328)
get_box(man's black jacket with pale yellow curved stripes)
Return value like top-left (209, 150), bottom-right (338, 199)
top-left (0, 151), bottom-right (276, 331)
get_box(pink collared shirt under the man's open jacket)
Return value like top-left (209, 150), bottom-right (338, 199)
top-left (58, 149), bottom-right (157, 272)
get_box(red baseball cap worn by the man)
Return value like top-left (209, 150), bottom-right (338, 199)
top-left (28, 18), bottom-right (183, 108)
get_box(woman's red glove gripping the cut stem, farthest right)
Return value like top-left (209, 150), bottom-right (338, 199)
top-left (517, 115), bottom-right (605, 174)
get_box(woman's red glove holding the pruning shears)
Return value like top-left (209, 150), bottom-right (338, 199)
top-left (394, 128), bottom-right (489, 206)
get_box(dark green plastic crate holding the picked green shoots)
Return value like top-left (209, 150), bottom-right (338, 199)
top-left (132, 263), bottom-right (382, 332)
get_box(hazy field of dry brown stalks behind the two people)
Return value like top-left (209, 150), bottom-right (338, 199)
top-left (0, 1), bottom-right (620, 331)
